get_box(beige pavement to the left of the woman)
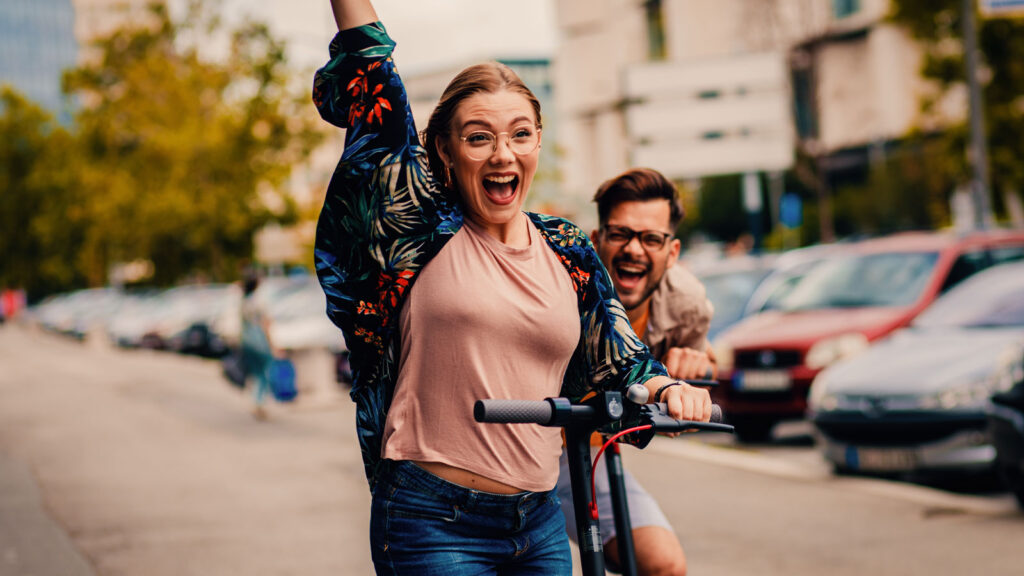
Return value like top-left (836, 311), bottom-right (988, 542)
top-left (0, 326), bottom-right (373, 576)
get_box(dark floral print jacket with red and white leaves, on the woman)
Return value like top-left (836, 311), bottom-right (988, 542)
top-left (313, 23), bottom-right (666, 490)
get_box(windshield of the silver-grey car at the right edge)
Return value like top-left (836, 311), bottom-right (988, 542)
top-left (913, 264), bottom-right (1024, 328)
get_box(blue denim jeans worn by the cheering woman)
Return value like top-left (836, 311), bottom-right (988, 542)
top-left (370, 461), bottom-right (572, 576)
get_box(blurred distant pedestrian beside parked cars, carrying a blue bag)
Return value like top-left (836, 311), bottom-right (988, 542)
top-left (242, 274), bottom-right (274, 420)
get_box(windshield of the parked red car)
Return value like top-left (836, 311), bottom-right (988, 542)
top-left (779, 252), bottom-right (939, 312)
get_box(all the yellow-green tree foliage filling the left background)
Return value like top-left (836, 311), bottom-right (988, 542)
top-left (0, 2), bottom-right (321, 294)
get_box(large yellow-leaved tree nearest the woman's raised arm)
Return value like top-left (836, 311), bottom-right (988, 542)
top-left (65, 1), bottom-right (321, 285)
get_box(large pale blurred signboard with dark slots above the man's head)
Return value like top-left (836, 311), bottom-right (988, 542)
top-left (625, 52), bottom-right (796, 179)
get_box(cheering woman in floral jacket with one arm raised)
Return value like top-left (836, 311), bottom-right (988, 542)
top-left (313, 0), bottom-right (711, 574)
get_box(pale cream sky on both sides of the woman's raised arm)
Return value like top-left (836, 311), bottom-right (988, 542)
top-left (210, 0), bottom-right (556, 73)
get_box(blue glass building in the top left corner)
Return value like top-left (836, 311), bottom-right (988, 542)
top-left (0, 0), bottom-right (78, 123)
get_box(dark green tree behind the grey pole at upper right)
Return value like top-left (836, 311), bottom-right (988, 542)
top-left (891, 0), bottom-right (1024, 219)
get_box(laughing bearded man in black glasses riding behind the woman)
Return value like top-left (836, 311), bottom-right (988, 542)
top-left (558, 168), bottom-right (716, 575)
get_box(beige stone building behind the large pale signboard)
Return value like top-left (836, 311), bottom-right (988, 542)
top-left (555, 0), bottom-right (966, 233)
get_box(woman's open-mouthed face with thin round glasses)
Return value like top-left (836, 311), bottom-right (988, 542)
top-left (437, 90), bottom-right (541, 239)
